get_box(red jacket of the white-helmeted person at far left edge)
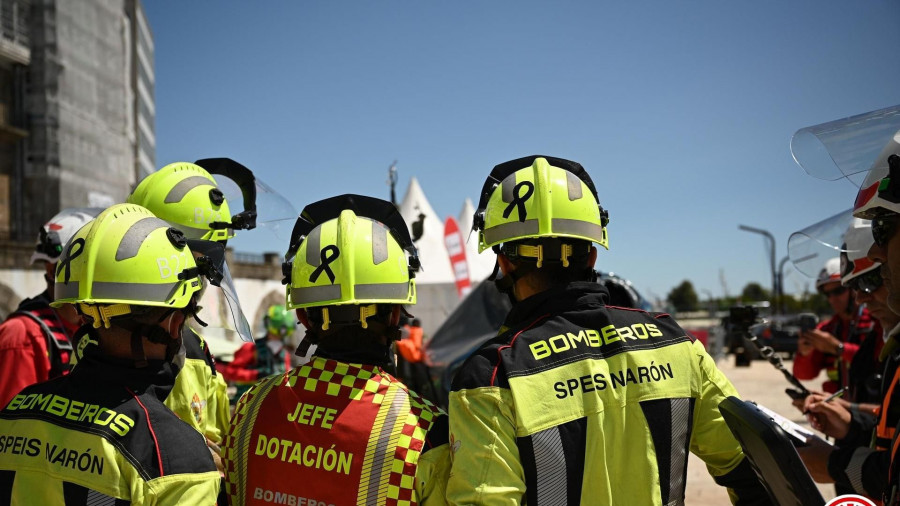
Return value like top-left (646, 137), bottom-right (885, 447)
top-left (0, 308), bottom-right (77, 406)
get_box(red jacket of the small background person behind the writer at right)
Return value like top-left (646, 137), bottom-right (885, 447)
top-left (794, 309), bottom-right (882, 393)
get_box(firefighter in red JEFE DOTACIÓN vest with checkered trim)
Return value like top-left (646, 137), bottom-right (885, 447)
top-left (225, 195), bottom-right (449, 506)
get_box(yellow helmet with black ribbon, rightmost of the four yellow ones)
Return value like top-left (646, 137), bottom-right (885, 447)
top-left (473, 155), bottom-right (609, 263)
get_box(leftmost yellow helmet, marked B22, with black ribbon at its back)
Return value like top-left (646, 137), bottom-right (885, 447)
top-left (52, 204), bottom-right (206, 327)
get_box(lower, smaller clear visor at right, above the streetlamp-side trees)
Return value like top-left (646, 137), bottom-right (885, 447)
top-left (788, 209), bottom-right (865, 278)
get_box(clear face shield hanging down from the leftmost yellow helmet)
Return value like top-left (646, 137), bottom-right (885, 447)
top-left (186, 240), bottom-right (253, 342)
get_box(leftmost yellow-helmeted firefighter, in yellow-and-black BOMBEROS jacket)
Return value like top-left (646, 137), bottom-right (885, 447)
top-left (0, 204), bottom-right (220, 505)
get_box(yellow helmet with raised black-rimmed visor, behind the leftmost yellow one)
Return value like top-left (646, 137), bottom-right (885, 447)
top-left (127, 158), bottom-right (256, 241)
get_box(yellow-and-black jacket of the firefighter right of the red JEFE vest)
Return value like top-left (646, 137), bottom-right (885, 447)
top-left (447, 282), bottom-right (769, 506)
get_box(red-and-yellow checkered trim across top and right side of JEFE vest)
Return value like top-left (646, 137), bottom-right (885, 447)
top-left (284, 357), bottom-right (441, 506)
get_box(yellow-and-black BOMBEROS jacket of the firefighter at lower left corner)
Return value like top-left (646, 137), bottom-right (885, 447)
top-left (0, 346), bottom-right (220, 505)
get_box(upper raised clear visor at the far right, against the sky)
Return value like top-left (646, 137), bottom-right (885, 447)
top-left (791, 105), bottom-right (900, 186)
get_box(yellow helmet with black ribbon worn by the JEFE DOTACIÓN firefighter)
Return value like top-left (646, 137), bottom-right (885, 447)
top-left (283, 195), bottom-right (419, 328)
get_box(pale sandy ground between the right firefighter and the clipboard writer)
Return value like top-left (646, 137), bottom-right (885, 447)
top-left (685, 357), bottom-right (835, 506)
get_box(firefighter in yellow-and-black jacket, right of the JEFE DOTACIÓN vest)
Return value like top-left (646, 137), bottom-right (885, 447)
top-left (447, 156), bottom-right (769, 505)
